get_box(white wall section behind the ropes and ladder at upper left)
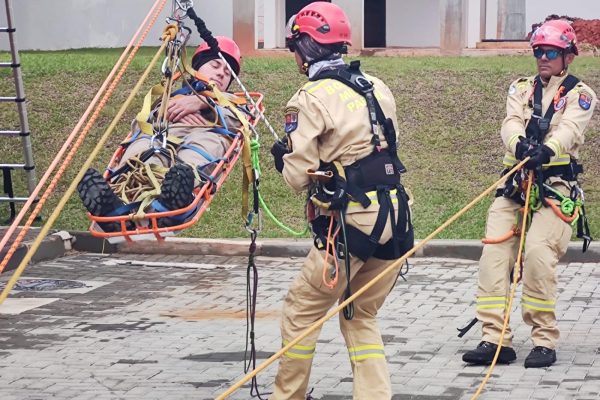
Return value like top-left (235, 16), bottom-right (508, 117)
top-left (0, 0), bottom-right (233, 50)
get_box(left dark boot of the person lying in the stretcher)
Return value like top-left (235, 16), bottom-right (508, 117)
top-left (77, 168), bottom-right (125, 232)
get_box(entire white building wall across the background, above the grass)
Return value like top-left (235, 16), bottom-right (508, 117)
top-left (0, 0), bottom-right (600, 50)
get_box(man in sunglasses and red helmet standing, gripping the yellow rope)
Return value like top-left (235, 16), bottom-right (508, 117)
top-left (463, 20), bottom-right (596, 368)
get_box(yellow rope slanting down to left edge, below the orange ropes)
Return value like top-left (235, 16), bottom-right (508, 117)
top-left (0, 42), bottom-right (166, 305)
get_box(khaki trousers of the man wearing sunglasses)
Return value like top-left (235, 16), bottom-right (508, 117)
top-left (477, 192), bottom-right (572, 349)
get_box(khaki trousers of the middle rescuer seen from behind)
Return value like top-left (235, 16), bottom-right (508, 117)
top-left (269, 212), bottom-right (400, 400)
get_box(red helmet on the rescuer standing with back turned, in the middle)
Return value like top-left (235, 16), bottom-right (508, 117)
top-left (287, 1), bottom-right (352, 45)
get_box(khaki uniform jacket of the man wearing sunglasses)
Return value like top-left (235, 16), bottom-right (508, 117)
top-left (501, 75), bottom-right (597, 166)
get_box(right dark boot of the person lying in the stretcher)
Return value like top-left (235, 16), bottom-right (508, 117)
top-left (157, 164), bottom-right (194, 227)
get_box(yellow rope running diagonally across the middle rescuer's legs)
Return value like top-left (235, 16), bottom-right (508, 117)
top-left (215, 157), bottom-right (529, 400)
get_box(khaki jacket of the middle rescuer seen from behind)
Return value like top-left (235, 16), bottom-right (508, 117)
top-left (283, 74), bottom-right (398, 192)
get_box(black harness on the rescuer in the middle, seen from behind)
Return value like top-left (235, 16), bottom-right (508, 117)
top-left (311, 61), bottom-right (414, 261)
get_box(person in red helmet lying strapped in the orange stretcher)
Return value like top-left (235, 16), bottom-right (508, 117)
top-left (77, 36), bottom-right (243, 232)
